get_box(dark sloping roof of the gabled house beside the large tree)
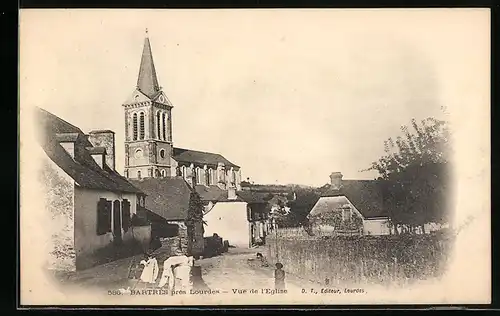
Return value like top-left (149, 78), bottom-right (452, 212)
top-left (318, 180), bottom-right (388, 218)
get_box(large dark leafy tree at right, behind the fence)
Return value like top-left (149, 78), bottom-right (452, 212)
top-left (367, 118), bottom-right (451, 233)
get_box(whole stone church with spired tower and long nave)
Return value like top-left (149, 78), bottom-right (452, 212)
top-left (123, 32), bottom-right (241, 190)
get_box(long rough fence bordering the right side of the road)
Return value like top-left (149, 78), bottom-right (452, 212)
top-left (266, 228), bottom-right (452, 285)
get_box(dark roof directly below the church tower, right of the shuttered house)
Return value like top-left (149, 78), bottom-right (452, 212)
top-left (130, 177), bottom-right (192, 220)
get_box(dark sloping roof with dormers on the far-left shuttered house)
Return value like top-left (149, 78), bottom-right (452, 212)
top-left (35, 108), bottom-right (142, 193)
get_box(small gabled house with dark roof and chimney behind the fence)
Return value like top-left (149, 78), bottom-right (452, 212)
top-left (308, 172), bottom-right (392, 235)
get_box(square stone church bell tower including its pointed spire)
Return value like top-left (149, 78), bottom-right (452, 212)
top-left (123, 29), bottom-right (173, 179)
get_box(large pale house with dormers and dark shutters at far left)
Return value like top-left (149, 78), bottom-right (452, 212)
top-left (34, 108), bottom-right (151, 271)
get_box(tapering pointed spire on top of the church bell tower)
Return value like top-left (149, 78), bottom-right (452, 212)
top-left (137, 29), bottom-right (160, 98)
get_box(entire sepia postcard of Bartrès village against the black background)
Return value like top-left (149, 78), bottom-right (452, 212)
top-left (18, 8), bottom-right (491, 306)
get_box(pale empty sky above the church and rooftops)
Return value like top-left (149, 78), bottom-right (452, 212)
top-left (20, 9), bottom-right (490, 186)
